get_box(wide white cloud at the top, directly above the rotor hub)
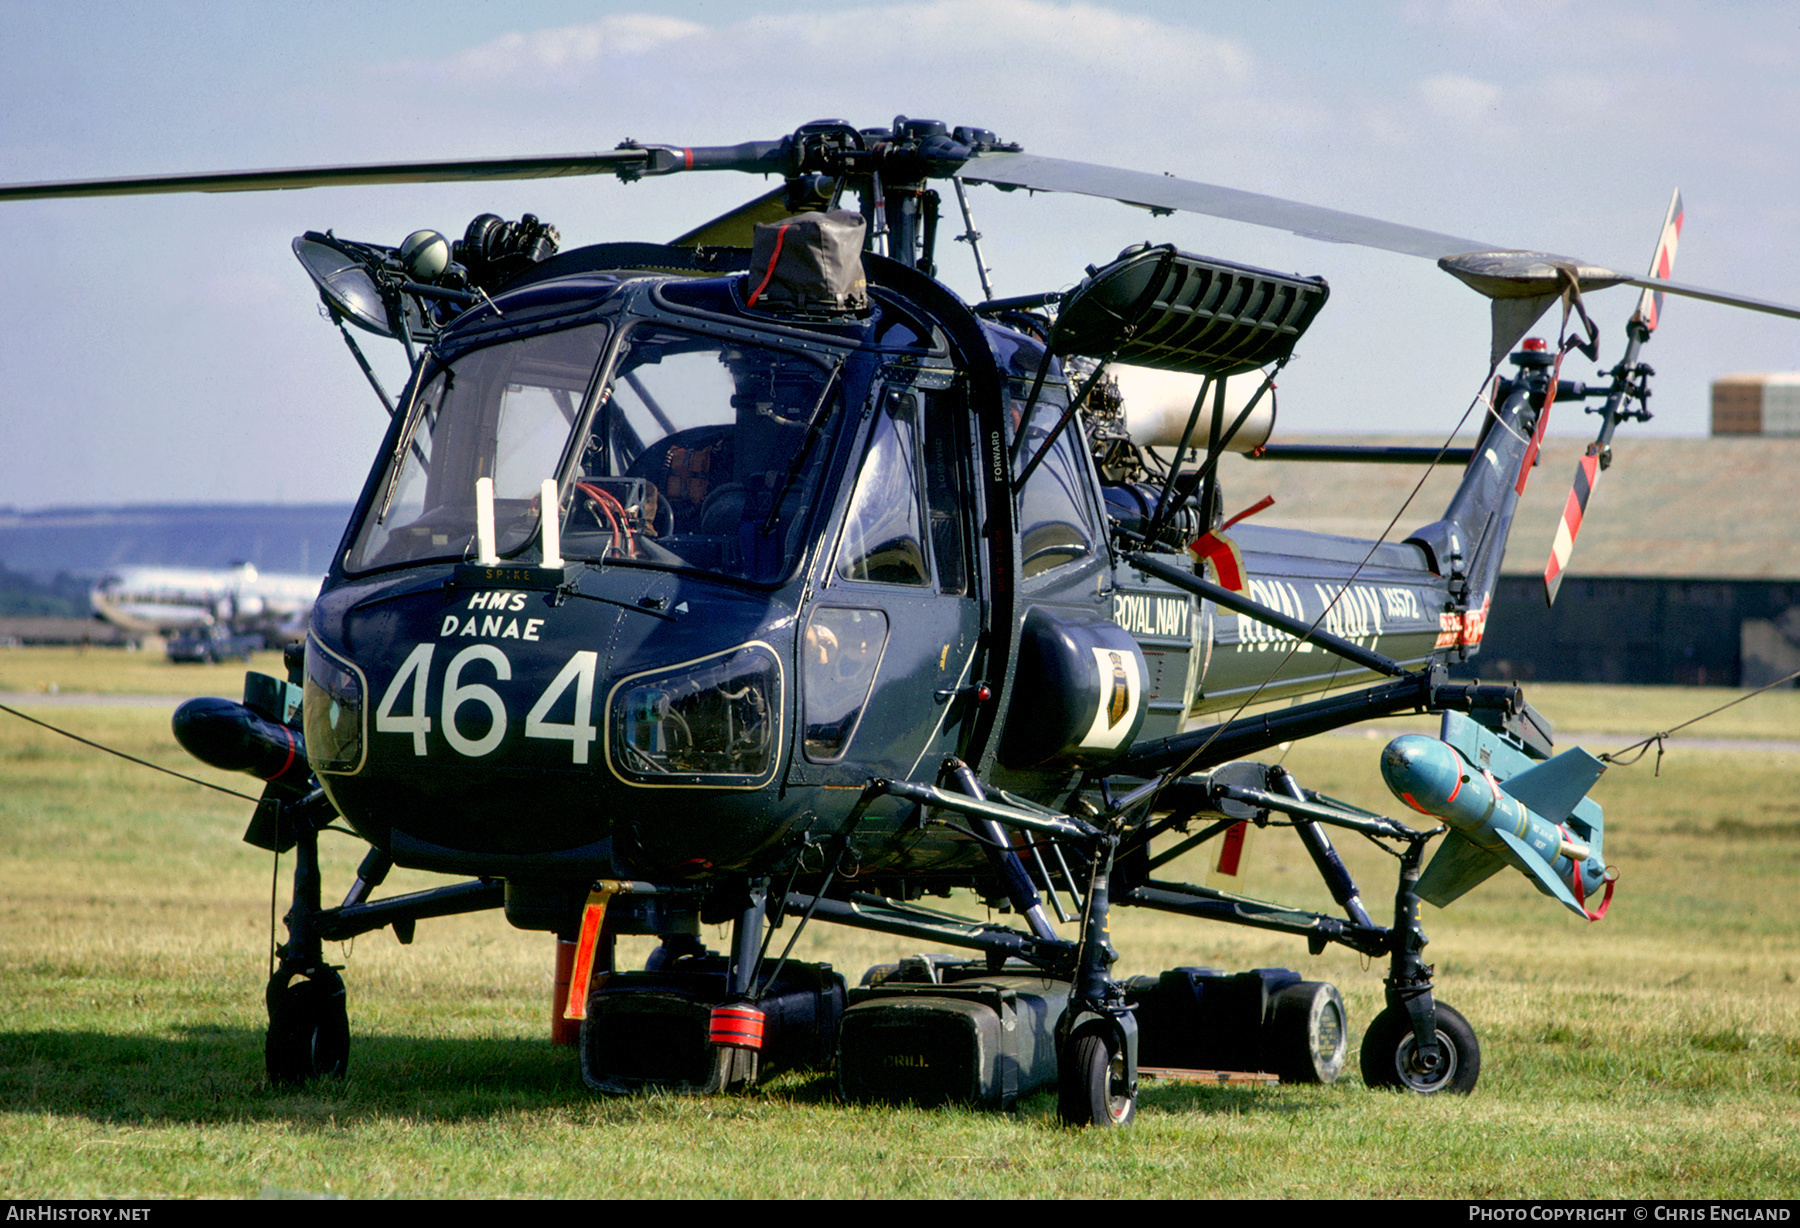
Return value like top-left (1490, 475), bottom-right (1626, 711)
top-left (392, 0), bottom-right (1255, 122)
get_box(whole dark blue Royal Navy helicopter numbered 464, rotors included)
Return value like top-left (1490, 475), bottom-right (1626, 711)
top-left (0, 117), bottom-right (1800, 1125)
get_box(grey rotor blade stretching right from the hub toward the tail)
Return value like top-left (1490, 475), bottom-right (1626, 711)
top-left (956, 153), bottom-right (1505, 259)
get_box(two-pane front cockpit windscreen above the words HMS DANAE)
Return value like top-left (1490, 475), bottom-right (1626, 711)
top-left (346, 321), bottom-right (844, 583)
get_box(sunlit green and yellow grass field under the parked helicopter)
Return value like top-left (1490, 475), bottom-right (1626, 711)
top-left (0, 652), bottom-right (1800, 1197)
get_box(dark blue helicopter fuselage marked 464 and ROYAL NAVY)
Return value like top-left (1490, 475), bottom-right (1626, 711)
top-left (306, 243), bottom-right (1510, 893)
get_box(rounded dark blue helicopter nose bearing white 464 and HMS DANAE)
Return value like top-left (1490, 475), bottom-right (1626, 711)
top-left (306, 569), bottom-right (792, 873)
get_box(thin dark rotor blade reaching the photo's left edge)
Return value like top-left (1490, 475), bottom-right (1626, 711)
top-left (0, 149), bottom-right (655, 202)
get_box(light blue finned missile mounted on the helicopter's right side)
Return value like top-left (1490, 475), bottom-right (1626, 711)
top-left (1381, 733), bottom-right (1616, 920)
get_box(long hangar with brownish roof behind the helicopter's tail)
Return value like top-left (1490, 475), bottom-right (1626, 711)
top-left (1220, 435), bottom-right (1800, 686)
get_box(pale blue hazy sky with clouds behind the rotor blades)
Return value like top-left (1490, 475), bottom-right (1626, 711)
top-left (0, 0), bottom-right (1800, 510)
